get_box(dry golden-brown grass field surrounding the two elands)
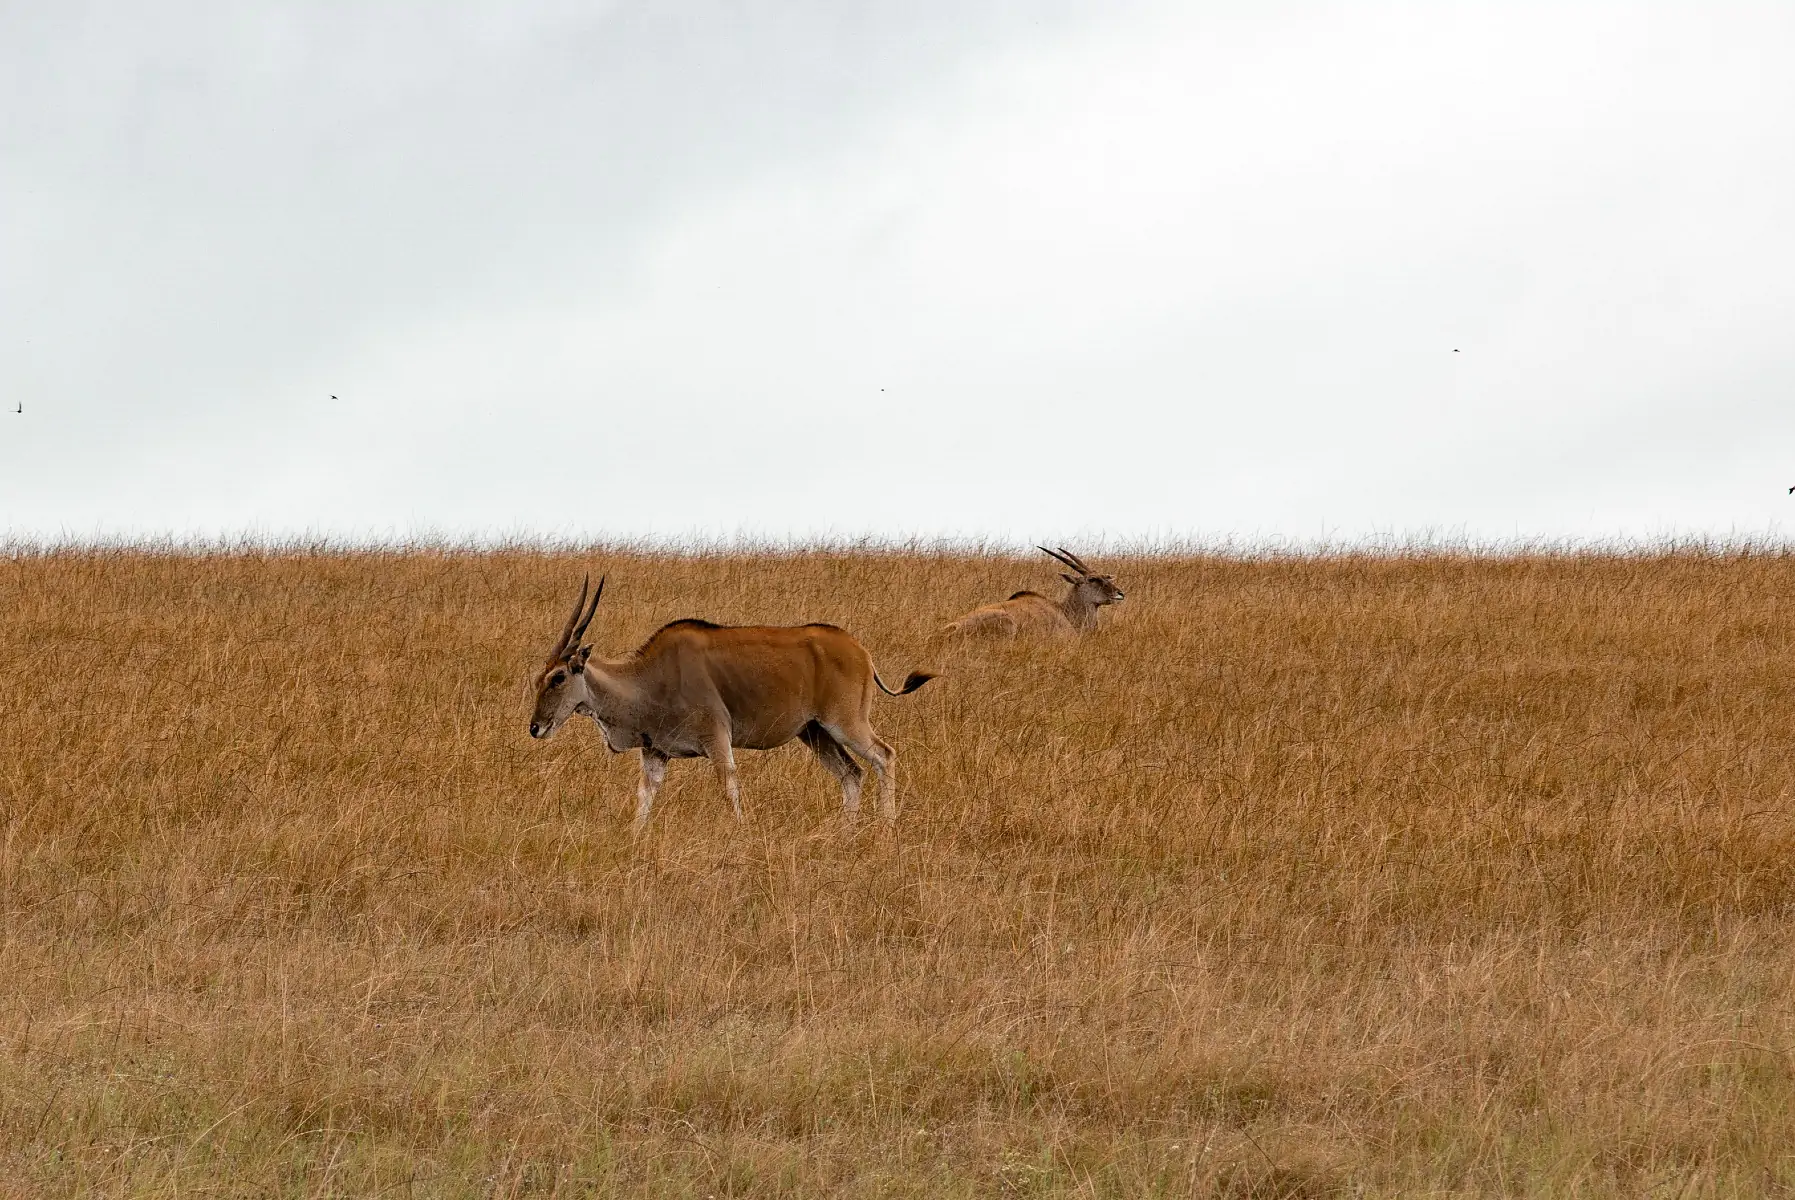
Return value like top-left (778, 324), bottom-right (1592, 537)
top-left (0, 551), bottom-right (1795, 1196)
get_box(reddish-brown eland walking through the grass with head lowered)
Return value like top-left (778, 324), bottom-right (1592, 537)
top-left (530, 576), bottom-right (935, 832)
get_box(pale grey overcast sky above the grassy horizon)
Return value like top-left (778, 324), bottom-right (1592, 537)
top-left (0, 0), bottom-right (1795, 543)
